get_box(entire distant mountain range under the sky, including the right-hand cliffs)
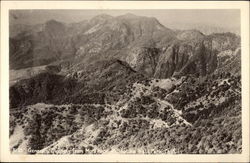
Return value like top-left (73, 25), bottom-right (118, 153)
top-left (10, 14), bottom-right (239, 77)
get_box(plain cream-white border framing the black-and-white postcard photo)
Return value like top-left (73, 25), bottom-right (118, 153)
top-left (0, 1), bottom-right (249, 162)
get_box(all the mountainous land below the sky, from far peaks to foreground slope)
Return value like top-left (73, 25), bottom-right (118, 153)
top-left (9, 14), bottom-right (241, 154)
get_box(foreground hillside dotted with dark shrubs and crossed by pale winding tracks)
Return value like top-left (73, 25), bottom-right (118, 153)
top-left (10, 72), bottom-right (241, 154)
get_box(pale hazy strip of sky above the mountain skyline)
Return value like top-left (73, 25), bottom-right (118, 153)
top-left (10, 9), bottom-right (240, 29)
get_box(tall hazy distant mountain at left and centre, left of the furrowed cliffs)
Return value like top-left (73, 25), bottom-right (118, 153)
top-left (10, 15), bottom-right (174, 69)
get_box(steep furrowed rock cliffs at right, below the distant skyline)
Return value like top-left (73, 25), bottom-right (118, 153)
top-left (126, 31), bottom-right (239, 78)
